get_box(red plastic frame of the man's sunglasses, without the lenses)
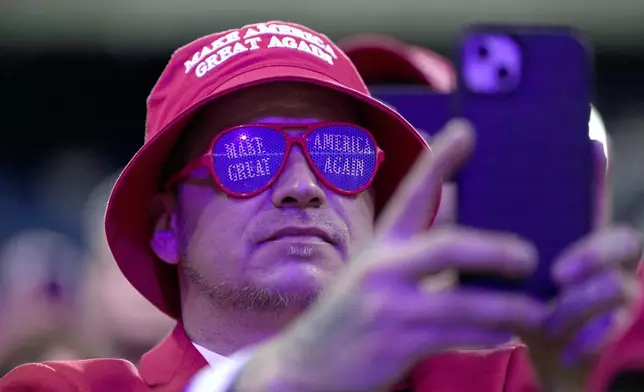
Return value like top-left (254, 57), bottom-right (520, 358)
top-left (165, 122), bottom-right (385, 199)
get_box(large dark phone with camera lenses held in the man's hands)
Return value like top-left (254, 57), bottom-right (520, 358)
top-left (454, 25), bottom-right (594, 300)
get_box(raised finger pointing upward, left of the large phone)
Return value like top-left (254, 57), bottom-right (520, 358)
top-left (376, 120), bottom-right (474, 239)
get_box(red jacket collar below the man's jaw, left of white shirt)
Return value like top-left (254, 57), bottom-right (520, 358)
top-left (139, 322), bottom-right (208, 391)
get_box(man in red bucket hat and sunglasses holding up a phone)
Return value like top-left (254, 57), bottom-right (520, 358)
top-left (0, 22), bottom-right (644, 392)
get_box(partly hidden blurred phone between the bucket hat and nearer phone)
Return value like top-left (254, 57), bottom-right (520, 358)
top-left (369, 85), bottom-right (452, 139)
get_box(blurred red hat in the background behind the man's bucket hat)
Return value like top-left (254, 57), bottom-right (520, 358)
top-left (338, 34), bottom-right (456, 93)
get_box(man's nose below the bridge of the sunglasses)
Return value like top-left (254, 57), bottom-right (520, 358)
top-left (272, 146), bottom-right (327, 208)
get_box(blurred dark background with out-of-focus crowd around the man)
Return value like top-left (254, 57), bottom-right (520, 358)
top-left (0, 0), bottom-right (644, 375)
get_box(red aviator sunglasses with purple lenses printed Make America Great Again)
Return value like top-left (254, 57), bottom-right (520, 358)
top-left (166, 122), bottom-right (385, 198)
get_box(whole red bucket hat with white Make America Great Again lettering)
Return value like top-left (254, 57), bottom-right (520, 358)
top-left (105, 21), bottom-right (429, 319)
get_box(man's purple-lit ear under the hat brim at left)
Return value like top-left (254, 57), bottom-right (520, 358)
top-left (150, 193), bottom-right (180, 264)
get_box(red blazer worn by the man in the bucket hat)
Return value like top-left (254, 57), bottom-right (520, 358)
top-left (0, 313), bottom-right (644, 392)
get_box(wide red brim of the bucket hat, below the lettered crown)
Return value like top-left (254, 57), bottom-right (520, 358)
top-left (105, 66), bottom-right (429, 319)
